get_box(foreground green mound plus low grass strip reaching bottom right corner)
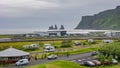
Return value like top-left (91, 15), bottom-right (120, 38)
top-left (26, 60), bottom-right (120, 68)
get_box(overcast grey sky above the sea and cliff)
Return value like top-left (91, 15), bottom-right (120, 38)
top-left (0, 0), bottom-right (120, 33)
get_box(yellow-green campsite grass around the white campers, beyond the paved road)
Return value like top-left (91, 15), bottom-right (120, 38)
top-left (0, 40), bottom-right (102, 58)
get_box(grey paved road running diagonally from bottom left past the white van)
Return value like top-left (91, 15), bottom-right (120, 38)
top-left (0, 52), bottom-right (91, 68)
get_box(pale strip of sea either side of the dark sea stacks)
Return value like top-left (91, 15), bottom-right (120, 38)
top-left (0, 29), bottom-right (120, 34)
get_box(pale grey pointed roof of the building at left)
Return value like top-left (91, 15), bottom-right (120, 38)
top-left (0, 48), bottom-right (29, 57)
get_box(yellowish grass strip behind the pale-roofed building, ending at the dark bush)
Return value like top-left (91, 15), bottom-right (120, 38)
top-left (0, 41), bottom-right (61, 50)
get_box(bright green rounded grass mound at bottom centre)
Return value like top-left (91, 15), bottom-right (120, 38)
top-left (26, 60), bottom-right (86, 68)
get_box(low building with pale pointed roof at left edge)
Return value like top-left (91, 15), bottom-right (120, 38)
top-left (0, 47), bottom-right (29, 64)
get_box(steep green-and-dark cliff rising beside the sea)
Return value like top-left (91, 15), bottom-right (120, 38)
top-left (76, 6), bottom-right (120, 30)
